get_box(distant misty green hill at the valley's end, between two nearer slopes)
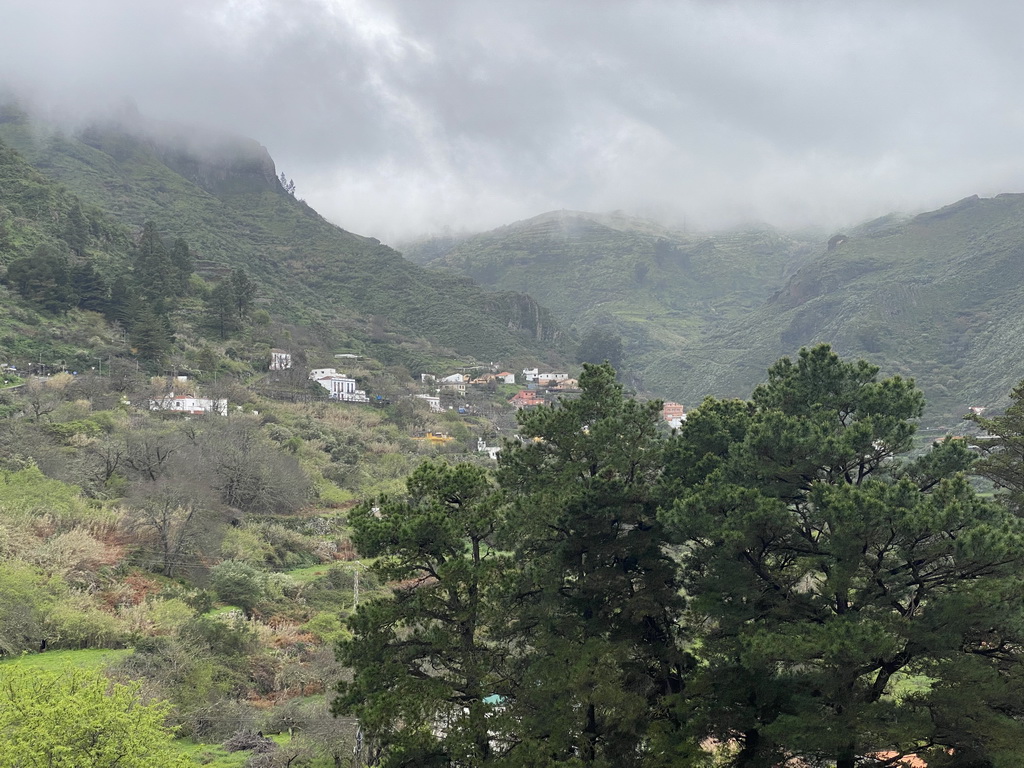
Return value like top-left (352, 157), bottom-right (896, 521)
top-left (402, 211), bottom-right (823, 396)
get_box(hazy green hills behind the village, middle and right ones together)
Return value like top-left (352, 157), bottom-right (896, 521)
top-left (404, 195), bottom-right (1024, 427)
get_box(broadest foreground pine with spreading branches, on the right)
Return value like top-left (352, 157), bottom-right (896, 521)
top-left (665, 346), bottom-right (1024, 768)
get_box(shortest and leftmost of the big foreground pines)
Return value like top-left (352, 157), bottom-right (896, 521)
top-left (335, 464), bottom-right (508, 766)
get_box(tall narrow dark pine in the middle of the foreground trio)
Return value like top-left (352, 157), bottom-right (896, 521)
top-left (499, 365), bottom-right (689, 768)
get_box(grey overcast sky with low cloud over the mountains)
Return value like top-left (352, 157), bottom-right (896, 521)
top-left (0, 0), bottom-right (1024, 242)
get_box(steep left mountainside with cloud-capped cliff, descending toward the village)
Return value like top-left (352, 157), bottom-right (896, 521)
top-left (0, 108), bottom-right (560, 368)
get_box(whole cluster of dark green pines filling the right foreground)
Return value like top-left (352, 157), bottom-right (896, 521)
top-left (335, 346), bottom-right (1024, 768)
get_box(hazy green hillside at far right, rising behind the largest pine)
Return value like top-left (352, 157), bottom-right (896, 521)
top-left (676, 195), bottom-right (1024, 425)
